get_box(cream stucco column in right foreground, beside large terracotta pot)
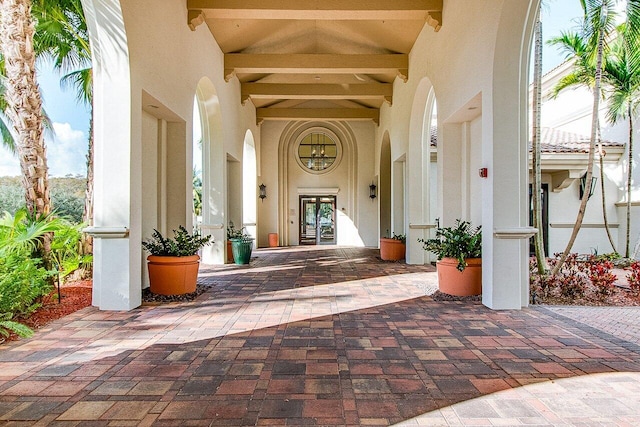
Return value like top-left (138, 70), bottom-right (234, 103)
top-left (482, 0), bottom-right (538, 309)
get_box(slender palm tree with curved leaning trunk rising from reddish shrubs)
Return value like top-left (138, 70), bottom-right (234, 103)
top-left (552, 0), bottom-right (616, 275)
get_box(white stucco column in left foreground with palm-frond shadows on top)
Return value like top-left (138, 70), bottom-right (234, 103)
top-left (82, 0), bottom-right (142, 310)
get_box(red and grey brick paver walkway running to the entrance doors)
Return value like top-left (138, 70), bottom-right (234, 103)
top-left (0, 247), bottom-right (640, 426)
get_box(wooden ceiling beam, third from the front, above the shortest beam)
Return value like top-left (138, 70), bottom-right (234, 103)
top-left (241, 83), bottom-right (393, 104)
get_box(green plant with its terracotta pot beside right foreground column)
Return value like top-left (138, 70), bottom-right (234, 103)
top-left (418, 219), bottom-right (482, 296)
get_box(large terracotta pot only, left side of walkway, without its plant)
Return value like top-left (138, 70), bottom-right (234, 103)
top-left (147, 255), bottom-right (200, 295)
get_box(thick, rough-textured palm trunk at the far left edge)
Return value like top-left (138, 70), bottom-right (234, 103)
top-left (0, 0), bottom-right (51, 221)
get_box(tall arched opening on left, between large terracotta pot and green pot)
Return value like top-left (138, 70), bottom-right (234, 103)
top-left (193, 78), bottom-right (226, 264)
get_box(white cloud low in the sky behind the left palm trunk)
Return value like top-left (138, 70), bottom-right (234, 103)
top-left (0, 122), bottom-right (88, 177)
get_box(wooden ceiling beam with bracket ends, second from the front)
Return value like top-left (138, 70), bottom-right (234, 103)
top-left (224, 53), bottom-right (409, 81)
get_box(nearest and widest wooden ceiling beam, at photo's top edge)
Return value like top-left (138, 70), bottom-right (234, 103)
top-left (187, 0), bottom-right (443, 21)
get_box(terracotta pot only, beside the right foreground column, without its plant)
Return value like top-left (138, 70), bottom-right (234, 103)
top-left (436, 258), bottom-right (482, 297)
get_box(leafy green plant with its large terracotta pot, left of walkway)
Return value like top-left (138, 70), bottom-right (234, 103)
top-left (142, 226), bottom-right (211, 295)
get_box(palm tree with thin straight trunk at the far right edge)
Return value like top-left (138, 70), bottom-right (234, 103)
top-left (604, 29), bottom-right (640, 258)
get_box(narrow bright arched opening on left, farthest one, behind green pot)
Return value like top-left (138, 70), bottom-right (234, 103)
top-left (242, 131), bottom-right (258, 246)
